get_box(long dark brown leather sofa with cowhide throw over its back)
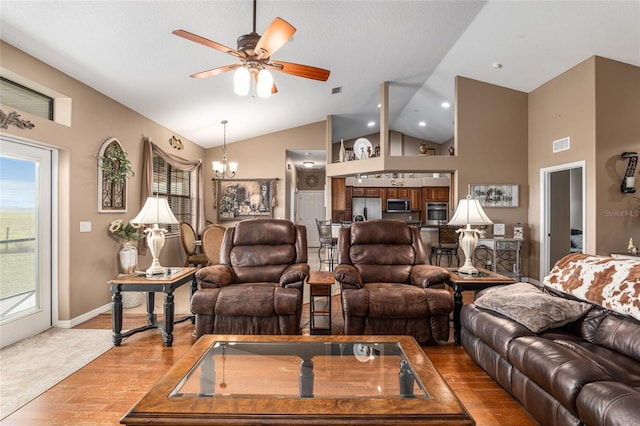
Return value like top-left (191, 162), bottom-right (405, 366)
top-left (461, 253), bottom-right (640, 426)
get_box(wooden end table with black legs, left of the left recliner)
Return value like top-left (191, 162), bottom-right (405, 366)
top-left (109, 267), bottom-right (197, 347)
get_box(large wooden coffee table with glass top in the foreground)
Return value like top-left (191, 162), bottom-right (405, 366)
top-left (120, 335), bottom-right (475, 425)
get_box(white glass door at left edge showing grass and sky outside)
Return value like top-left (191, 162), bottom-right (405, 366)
top-left (0, 137), bottom-right (56, 347)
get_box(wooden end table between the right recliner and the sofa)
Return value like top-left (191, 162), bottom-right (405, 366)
top-left (446, 268), bottom-right (515, 344)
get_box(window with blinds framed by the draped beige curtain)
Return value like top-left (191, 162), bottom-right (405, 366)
top-left (153, 153), bottom-right (195, 234)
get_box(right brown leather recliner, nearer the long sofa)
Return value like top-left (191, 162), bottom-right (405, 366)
top-left (334, 219), bottom-right (453, 343)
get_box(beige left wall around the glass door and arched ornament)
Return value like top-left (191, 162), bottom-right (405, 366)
top-left (0, 42), bottom-right (204, 321)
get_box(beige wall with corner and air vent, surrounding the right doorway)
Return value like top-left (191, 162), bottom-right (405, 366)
top-left (529, 57), bottom-right (640, 276)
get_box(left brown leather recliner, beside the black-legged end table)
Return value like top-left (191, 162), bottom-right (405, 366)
top-left (191, 219), bottom-right (309, 338)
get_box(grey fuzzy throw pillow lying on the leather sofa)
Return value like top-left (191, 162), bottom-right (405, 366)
top-left (474, 283), bottom-right (591, 333)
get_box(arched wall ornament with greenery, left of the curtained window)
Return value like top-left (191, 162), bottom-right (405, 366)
top-left (98, 138), bottom-right (133, 213)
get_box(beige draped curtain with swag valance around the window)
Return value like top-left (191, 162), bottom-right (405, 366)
top-left (140, 138), bottom-right (204, 234)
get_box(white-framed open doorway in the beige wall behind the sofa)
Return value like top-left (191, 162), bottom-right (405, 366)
top-left (540, 161), bottom-right (587, 278)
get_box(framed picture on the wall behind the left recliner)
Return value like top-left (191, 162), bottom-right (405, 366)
top-left (215, 179), bottom-right (276, 222)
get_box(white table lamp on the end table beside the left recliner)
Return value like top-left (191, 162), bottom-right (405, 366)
top-left (131, 197), bottom-right (178, 275)
